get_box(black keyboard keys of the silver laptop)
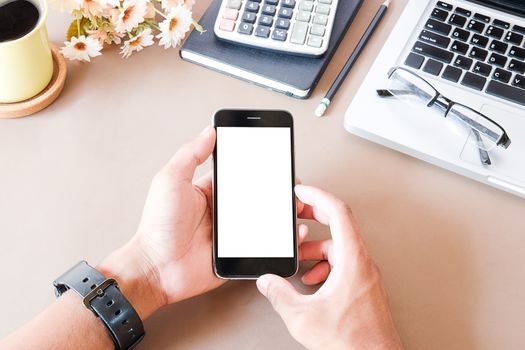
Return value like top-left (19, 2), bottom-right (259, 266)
top-left (405, 1), bottom-right (525, 106)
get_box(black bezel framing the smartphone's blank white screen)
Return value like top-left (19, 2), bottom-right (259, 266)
top-left (213, 109), bottom-right (298, 279)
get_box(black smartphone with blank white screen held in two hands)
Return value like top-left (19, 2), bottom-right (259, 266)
top-left (213, 110), bottom-right (298, 279)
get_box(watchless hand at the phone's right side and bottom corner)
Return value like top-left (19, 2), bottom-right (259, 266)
top-left (257, 185), bottom-right (402, 349)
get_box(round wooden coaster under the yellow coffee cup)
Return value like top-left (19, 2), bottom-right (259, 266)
top-left (0, 45), bottom-right (67, 119)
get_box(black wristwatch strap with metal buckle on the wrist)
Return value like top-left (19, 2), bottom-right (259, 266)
top-left (53, 261), bottom-right (145, 350)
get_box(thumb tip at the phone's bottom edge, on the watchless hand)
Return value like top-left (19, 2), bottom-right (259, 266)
top-left (257, 275), bottom-right (302, 319)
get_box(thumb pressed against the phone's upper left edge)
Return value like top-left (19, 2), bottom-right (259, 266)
top-left (164, 126), bottom-right (215, 181)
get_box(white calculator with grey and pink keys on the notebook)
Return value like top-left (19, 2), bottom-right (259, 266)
top-left (214, 0), bottom-right (344, 56)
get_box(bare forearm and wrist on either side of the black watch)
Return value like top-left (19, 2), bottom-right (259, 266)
top-left (0, 241), bottom-right (164, 350)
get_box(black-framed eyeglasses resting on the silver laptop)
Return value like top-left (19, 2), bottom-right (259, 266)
top-left (377, 67), bottom-right (511, 165)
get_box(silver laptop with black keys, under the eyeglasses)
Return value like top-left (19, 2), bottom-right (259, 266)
top-left (344, 0), bottom-right (525, 197)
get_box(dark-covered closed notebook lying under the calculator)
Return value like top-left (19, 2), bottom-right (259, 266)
top-left (180, 0), bottom-right (363, 98)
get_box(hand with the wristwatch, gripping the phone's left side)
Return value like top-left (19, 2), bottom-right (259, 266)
top-left (99, 127), bottom-right (224, 319)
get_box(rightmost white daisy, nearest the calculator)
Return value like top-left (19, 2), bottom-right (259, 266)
top-left (157, 5), bottom-right (193, 49)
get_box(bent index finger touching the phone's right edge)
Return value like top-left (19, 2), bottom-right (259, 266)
top-left (295, 185), bottom-right (361, 248)
